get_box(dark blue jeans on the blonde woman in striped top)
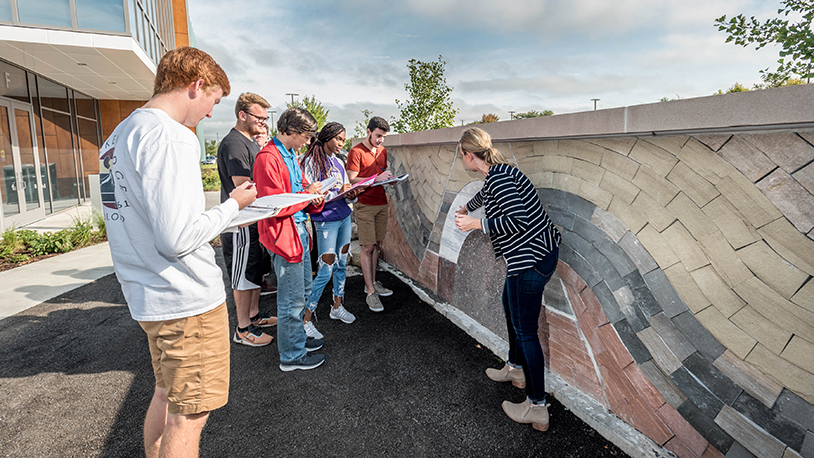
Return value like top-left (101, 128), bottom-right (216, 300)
top-left (503, 248), bottom-right (559, 404)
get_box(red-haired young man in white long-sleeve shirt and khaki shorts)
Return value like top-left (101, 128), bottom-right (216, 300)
top-left (100, 47), bottom-right (257, 458)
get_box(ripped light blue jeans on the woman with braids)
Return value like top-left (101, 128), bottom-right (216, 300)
top-left (308, 215), bottom-right (350, 311)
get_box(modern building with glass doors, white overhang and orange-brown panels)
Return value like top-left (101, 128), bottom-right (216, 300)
top-left (0, 0), bottom-right (194, 230)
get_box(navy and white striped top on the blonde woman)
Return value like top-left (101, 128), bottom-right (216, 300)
top-left (466, 164), bottom-right (562, 276)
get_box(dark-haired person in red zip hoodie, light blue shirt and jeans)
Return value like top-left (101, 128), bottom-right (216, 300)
top-left (253, 108), bottom-right (325, 371)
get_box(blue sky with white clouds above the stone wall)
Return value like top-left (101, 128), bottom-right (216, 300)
top-left (188, 0), bottom-right (779, 138)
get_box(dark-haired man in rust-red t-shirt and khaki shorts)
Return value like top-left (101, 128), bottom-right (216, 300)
top-left (346, 116), bottom-right (393, 312)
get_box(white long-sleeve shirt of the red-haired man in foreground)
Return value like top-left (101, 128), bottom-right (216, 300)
top-left (100, 109), bottom-right (238, 321)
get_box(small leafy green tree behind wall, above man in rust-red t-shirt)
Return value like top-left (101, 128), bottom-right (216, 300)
top-left (392, 56), bottom-right (458, 132)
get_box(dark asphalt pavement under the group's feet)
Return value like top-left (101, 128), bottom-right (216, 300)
top-left (0, 247), bottom-right (624, 457)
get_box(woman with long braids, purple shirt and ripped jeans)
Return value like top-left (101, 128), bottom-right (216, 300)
top-left (300, 122), bottom-right (358, 339)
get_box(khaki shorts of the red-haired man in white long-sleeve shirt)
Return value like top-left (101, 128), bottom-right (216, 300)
top-left (139, 302), bottom-right (230, 415)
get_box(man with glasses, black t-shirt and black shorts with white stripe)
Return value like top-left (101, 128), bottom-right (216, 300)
top-left (217, 92), bottom-right (277, 347)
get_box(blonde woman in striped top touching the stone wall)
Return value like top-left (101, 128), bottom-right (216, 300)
top-left (455, 127), bottom-right (561, 431)
